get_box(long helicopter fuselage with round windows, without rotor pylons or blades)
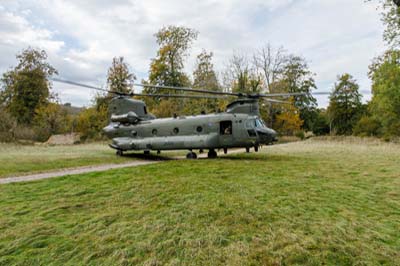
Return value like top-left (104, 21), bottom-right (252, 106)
top-left (104, 113), bottom-right (276, 151)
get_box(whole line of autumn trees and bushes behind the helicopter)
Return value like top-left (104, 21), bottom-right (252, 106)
top-left (0, 1), bottom-right (400, 141)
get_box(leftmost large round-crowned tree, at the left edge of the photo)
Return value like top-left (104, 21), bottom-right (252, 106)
top-left (0, 48), bottom-right (57, 125)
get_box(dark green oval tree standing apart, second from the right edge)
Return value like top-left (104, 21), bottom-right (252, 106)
top-left (328, 74), bottom-right (362, 135)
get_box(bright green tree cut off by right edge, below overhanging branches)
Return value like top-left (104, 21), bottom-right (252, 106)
top-left (369, 50), bottom-right (400, 137)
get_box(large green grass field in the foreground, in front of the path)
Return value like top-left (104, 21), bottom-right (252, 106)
top-left (0, 141), bottom-right (400, 265)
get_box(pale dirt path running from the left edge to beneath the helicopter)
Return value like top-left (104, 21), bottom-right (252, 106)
top-left (0, 149), bottom-right (247, 185)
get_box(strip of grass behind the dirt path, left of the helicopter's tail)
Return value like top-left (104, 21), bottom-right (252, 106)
top-left (0, 143), bottom-right (132, 178)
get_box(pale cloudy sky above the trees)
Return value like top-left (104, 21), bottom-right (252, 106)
top-left (0, 0), bottom-right (384, 106)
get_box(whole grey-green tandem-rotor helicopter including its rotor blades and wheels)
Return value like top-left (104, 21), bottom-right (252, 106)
top-left (52, 78), bottom-right (327, 159)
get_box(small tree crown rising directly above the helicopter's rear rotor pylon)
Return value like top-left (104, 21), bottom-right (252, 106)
top-left (107, 56), bottom-right (136, 93)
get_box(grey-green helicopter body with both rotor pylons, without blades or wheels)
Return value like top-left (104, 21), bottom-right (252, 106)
top-left (104, 97), bottom-right (276, 151)
